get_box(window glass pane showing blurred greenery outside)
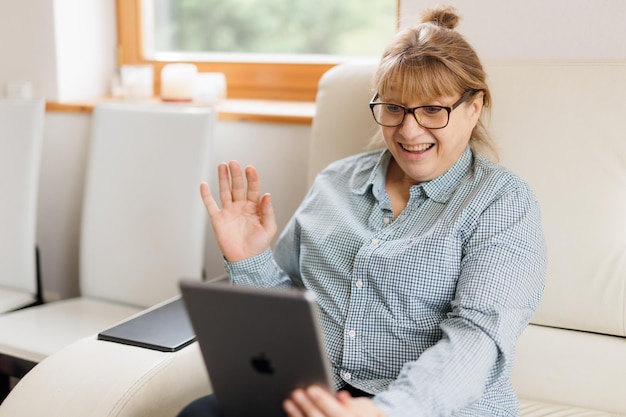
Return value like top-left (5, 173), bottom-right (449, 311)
top-left (143, 0), bottom-right (397, 58)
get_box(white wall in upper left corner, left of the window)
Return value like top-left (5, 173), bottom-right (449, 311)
top-left (0, 0), bottom-right (117, 101)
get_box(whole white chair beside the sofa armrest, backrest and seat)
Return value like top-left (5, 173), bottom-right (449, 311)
top-left (0, 103), bottom-right (215, 400)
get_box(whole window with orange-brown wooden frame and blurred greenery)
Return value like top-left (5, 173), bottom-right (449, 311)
top-left (117, 0), bottom-right (399, 101)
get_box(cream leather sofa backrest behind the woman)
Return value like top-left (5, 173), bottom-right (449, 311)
top-left (309, 62), bottom-right (626, 336)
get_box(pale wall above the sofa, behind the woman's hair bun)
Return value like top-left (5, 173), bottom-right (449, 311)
top-left (401, 0), bottom-right (626, 60)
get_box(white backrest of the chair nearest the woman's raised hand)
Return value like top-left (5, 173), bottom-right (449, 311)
top-left (79, 103), bottom-right (215, 307)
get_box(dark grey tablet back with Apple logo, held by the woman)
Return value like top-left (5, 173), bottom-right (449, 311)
top-left (181, 281), bottom-right (333, 417)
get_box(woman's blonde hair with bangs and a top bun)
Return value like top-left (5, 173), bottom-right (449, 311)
top-left (374, 6), bottom-right (497, 159)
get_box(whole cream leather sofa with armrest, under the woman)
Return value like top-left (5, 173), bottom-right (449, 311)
top-left (0, 62), bottom-right (626, 417)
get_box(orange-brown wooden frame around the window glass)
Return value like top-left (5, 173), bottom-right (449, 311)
top-left (116, 0), bottom-right (400, 101)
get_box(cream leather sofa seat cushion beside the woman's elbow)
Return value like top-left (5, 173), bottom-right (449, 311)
top-left (512, 324), bottom-right (626, 416)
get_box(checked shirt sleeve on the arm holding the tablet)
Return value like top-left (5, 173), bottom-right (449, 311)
top-left (374, 182), bottom-right (546, 417)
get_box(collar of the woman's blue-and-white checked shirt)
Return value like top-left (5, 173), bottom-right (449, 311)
top-left (353, 146), bottom-right (474, 203)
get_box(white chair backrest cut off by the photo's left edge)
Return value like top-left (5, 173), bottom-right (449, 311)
top-left (0, 99), bottom-right (45, 309)
